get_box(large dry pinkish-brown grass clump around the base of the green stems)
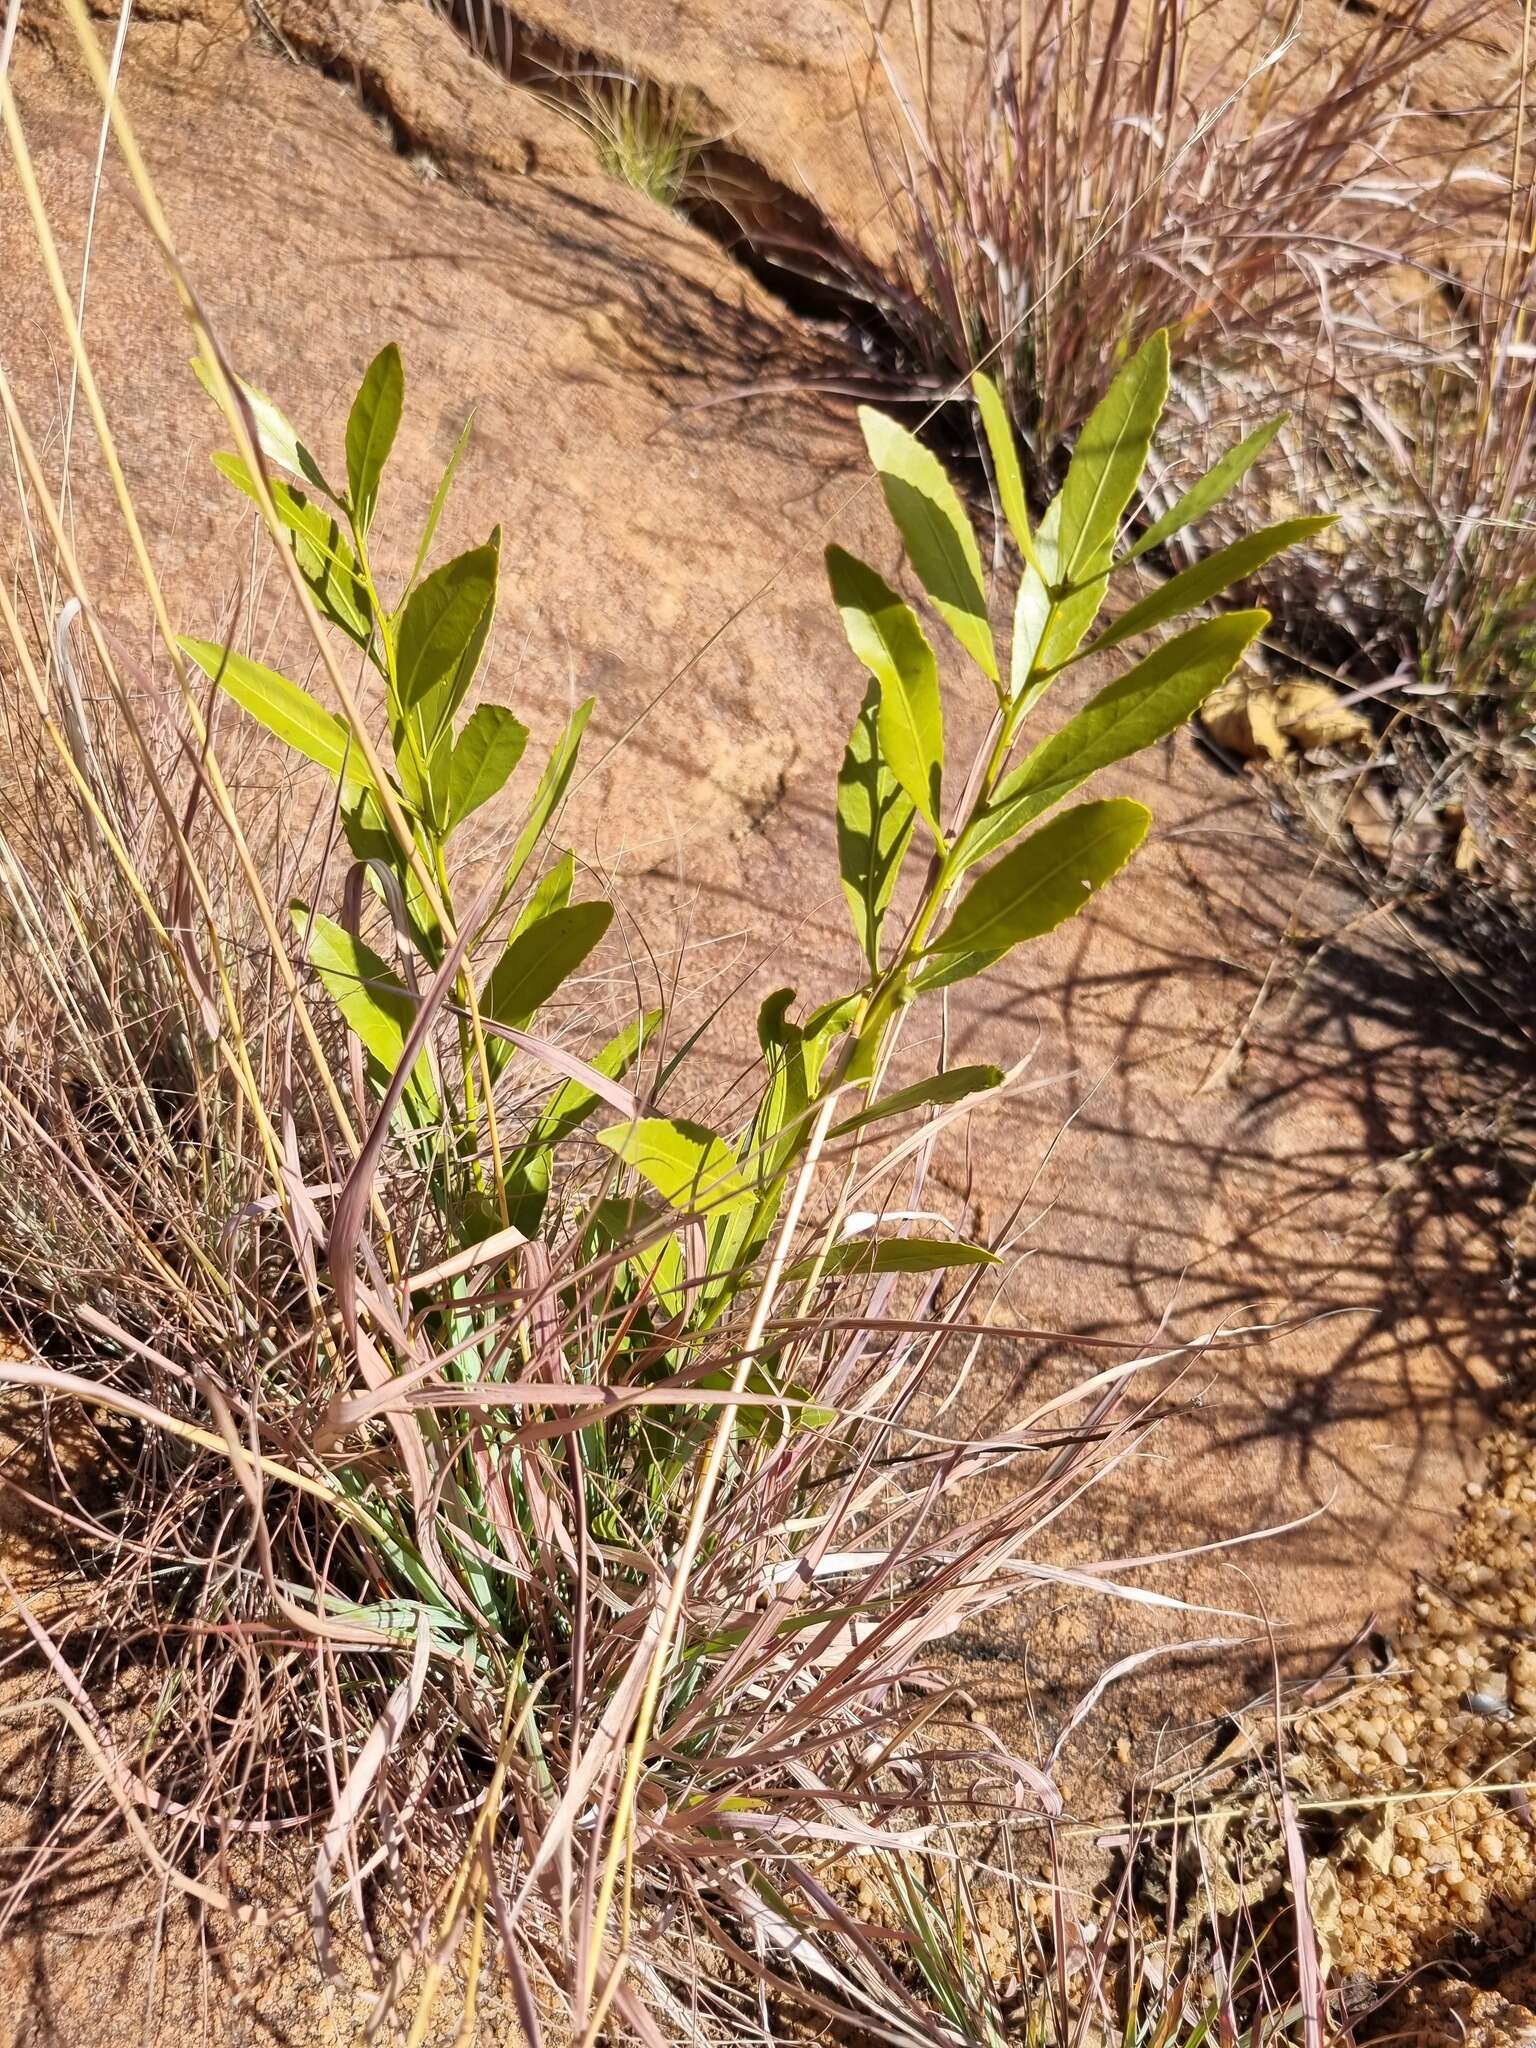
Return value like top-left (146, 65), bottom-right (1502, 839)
top-left (0, 16), bottom-right (1327, 2042)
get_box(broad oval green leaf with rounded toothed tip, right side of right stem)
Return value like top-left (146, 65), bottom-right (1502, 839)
top-left (928, 797), bottom-right (1151, 954)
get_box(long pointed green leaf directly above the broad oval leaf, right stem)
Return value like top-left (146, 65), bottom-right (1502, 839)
top-left (961, 612), bottom-right (1270, 868)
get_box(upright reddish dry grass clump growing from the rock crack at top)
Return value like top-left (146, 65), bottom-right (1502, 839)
top-left (870, 0), bottom-right (1470, 496)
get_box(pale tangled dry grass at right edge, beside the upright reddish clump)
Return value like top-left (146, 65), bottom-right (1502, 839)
top-left (1249, 123), bottom-right (1536, 717)
